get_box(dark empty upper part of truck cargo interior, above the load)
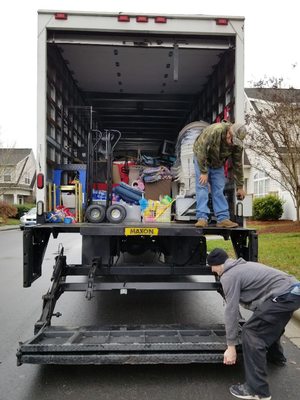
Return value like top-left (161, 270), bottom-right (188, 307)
top-left (48, 30), bottom-right (235, 157)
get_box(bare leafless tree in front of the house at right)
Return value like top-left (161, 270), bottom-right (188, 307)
top-left (246, 78), bottom-right (300, 222)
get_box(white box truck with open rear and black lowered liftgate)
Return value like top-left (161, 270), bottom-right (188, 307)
top-left (17, 11), bottom-right (257, 365)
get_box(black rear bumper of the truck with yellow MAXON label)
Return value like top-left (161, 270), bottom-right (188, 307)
top-left (23, 223), bottom-right (257, 287)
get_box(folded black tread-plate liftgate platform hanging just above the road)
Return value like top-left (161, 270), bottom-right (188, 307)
top-left (17, 325), bottom-right (241, 365)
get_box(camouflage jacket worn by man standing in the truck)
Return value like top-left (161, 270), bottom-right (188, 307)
top-left (194, 122), bottom-right (244, 188)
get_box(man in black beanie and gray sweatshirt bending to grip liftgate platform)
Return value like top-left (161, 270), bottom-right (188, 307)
top-left (207, 248), bottom-right (300, 400)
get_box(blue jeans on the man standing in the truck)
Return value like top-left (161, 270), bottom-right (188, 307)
top-left (194, 157), bottom-right (229, 222)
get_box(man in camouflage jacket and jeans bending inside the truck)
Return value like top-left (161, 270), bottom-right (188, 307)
top-left (194, 121), bottom-right (246, 228)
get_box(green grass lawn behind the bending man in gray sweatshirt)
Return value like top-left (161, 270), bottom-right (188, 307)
top-left (207, 233), bottom-right (300, 280)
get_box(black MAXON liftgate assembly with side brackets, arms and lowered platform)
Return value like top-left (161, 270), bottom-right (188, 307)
top-left (17, 226), bottom-right (257, 365)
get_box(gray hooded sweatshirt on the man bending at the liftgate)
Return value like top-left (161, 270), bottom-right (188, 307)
top-left (220, 258), bottom-right (297, 346)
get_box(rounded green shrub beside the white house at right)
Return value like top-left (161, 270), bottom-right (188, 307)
top-left (253, 195), bottom-right (284, 221)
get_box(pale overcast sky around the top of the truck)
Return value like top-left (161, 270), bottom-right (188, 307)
top-left (0, 0), bottom-right (300, 150)
